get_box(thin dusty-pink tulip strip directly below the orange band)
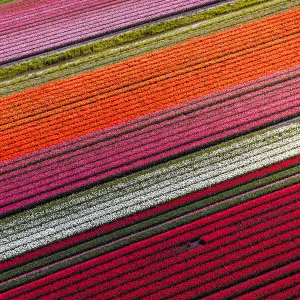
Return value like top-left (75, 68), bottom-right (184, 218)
top-left (1, 66), bottom-right (299, 175)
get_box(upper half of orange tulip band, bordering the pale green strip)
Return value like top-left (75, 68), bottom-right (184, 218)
top-left (1, 10), bottom-right (300, 124)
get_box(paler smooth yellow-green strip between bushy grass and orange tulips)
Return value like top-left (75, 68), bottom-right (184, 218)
top-left (0, 0), bottom-right (298, 97)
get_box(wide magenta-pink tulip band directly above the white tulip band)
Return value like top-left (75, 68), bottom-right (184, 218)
top-left (0, 72), bottom-right (300, 212)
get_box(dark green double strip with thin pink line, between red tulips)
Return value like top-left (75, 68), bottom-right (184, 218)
top-left (0, 165), bottom-right (300, 291)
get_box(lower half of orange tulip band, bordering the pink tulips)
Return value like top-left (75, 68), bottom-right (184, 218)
top-left (0, 35), bottom-right (300, 164)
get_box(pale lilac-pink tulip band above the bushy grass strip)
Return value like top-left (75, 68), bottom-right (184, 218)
top-left (0, 0), bottom-right (215, 62)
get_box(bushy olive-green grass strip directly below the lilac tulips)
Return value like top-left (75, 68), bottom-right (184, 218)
top-left (0, 0), bottom-right (286, 80)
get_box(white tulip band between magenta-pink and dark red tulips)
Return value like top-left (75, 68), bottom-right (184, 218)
top-left (0, 120), bottom-right (300, 260)
